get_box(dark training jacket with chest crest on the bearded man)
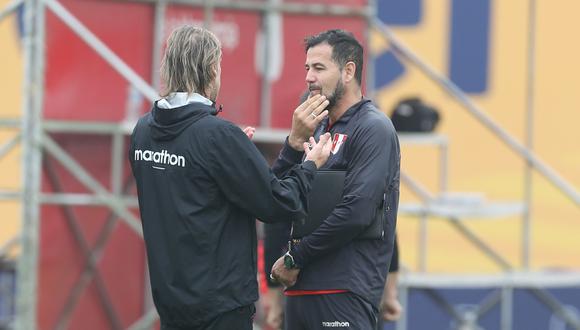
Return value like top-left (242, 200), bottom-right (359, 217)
top-left (273, 100), bottom-right (401, 309)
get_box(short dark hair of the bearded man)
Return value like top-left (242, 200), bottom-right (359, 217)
top-left (304, 29), bottom-right (363, 86)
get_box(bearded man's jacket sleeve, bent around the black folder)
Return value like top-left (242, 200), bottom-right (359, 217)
top-left (292, 120), bottom-right (398, 267)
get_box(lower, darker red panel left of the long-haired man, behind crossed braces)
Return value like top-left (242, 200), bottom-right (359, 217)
top-left (39, 135), bottom-right (145, 329)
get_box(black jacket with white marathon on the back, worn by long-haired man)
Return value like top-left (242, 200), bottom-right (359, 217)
top-left (129, 103), bottom-right (316, 327)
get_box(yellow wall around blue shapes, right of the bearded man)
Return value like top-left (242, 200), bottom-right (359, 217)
top-left (373, 0), bottom-right (580, 272)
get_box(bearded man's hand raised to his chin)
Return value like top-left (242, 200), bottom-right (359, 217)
top-left (288, 94), bottom-right (328, 150)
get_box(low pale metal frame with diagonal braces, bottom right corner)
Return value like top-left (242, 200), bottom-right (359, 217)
top-left (395, 271), bottom-right (580, 330)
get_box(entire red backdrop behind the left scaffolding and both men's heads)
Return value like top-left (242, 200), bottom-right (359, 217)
top-left (38, 0), bottom-right (365, 329)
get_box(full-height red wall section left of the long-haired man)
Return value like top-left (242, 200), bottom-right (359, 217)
top-left (38, 0), bottom-right (153, 322)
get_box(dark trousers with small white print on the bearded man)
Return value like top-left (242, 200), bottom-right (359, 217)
top-left (285, 292), bottom-right (378, 330)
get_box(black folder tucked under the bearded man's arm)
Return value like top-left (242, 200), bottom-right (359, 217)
top-left (292, 170), bottom-right (385, 239)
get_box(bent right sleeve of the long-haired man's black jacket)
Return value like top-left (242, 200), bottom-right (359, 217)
top-left (207, 125), bottom-right (316, 222)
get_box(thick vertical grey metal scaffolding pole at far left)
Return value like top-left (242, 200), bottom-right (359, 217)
top-left (15, 0), bottom-right (44, 330)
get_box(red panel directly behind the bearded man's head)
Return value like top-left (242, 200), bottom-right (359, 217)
top-left (272, 15), bottom-right (366, 128)
